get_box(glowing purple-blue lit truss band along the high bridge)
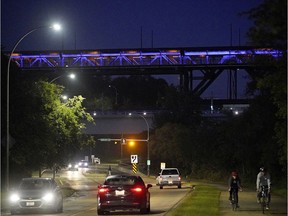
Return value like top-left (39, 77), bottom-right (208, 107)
top-left (12, 49), bottom-right (282, 67)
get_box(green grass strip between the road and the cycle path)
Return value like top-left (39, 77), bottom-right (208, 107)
top-left (167, 184), bottom-right (220, 216)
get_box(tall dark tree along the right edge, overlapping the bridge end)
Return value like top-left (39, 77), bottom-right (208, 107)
top-left (246, 0), bottom-right (287, 170)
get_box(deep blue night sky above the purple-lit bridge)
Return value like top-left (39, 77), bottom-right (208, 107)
top-left (1, 0), bottom-right (262, 98)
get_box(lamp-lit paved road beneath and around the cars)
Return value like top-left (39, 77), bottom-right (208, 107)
top-left (2, 165), bottom-right (191, 216)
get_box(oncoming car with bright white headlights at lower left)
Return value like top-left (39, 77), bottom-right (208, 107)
top-left (9, 178), bottom-right (63, 215)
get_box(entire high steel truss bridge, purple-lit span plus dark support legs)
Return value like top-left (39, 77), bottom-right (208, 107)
top-left (11, 47), bottom-right (282, 99)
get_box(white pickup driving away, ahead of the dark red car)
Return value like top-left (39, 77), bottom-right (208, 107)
top-left (156, 168), bottom-right (182, 189)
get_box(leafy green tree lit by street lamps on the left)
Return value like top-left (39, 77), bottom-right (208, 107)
top-left (11, 81), bottom-right (94, 178)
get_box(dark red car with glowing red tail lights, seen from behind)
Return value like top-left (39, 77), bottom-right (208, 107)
top-left (97, 175), bottom-right (152, 215)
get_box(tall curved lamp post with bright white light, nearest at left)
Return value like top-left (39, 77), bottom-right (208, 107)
top-left (6, 24), bottom-right (61, 191)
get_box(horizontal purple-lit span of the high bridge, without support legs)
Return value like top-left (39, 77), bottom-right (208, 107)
top-left (7, 47), bottom-right (281, 69)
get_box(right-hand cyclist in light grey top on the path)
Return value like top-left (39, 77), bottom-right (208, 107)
top-left (256, 167), bottom-right (271, 209)
